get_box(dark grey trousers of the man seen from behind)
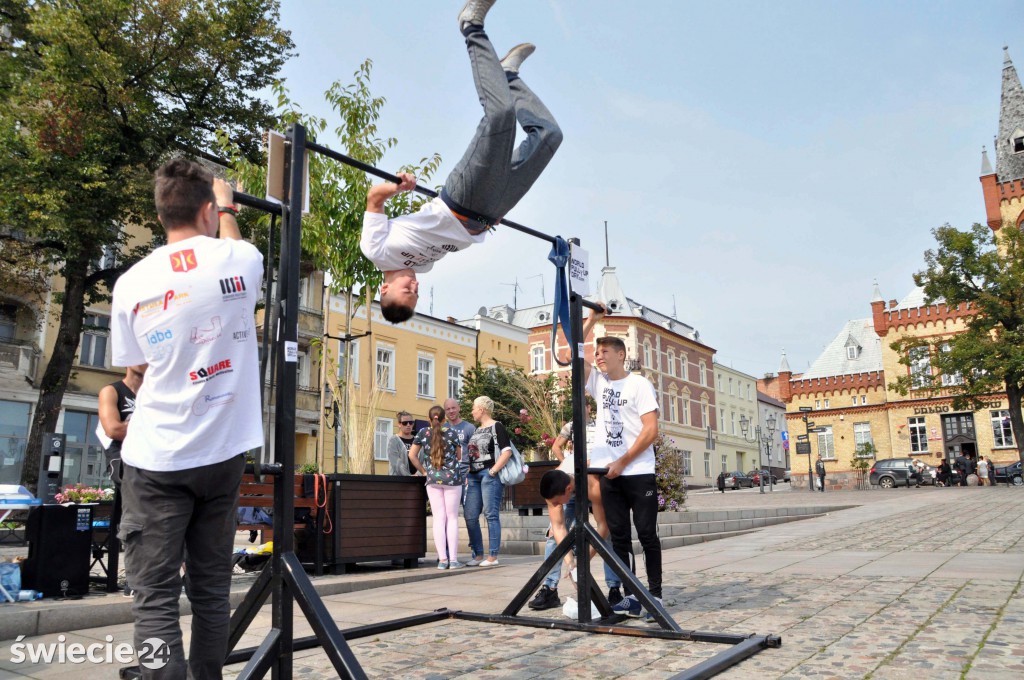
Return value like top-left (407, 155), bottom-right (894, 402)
top-left (118, 455), bottom-right (245, 680)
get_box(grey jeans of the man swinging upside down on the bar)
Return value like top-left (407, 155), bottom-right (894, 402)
top-left (444, 30), bottom-right (562, 219)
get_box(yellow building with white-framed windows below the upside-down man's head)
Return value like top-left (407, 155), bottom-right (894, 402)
top-left (317, 296), bottom-right (527, 474)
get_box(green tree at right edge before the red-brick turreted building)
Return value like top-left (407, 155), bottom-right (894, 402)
top-left (890, 224), bottom-right (1024, 460)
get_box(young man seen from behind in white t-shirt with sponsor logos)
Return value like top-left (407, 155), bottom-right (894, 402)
top-left (111, 159), bottom-right (263, 678)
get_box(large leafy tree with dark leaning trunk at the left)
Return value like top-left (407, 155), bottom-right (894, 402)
top-left (0, 0), bottom-right (293, 485)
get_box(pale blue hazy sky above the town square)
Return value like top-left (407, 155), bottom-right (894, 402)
top-left (268, 0), bottom-right (1024, 377)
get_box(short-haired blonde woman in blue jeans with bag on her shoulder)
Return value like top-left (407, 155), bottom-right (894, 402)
top-left (466, 396), bottom-right (512, 566)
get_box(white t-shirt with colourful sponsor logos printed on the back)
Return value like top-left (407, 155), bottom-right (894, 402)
top-left (111, 237), bottom-right (263, 471)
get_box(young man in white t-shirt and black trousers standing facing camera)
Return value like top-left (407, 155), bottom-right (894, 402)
top-left (584, 312), bottom-right (662, 621)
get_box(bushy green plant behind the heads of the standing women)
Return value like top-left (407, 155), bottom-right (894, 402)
top-left (460, 364), bottom-right (572, 454)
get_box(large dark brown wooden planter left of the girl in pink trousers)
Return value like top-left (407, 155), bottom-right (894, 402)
top-left (297, 474), bottom-right (427, 573)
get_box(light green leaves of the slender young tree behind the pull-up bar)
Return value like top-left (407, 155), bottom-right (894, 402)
top-left (220, 59), bottom-right (441, 299)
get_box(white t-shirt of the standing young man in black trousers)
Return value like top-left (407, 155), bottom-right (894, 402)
top-left (587, 368), bottom-right (657, 475)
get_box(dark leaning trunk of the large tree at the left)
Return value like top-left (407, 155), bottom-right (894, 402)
top-left (22, 254), bottom-right (89, 493)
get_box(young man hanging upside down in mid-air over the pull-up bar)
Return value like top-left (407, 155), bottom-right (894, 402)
top-left (359, 0), bottom-right (562, 324)
